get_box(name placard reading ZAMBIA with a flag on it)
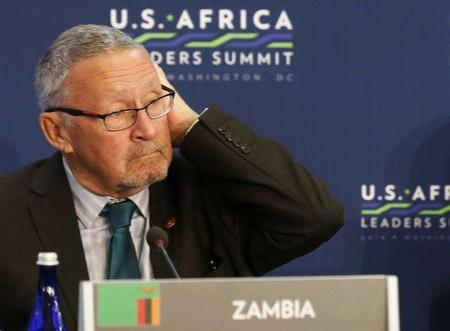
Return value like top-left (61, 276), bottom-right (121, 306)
top-left (79, 276), bottom-right (400, 331)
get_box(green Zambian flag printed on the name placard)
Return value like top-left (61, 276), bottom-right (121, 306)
top-left (96, 283), bottom-right (161, 327)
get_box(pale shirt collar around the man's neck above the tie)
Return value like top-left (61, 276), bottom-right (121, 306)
top-left (63, 156), bottom-right (150, 228)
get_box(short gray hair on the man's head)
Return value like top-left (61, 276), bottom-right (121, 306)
top-left (35, 24), bottom-right (145, 110)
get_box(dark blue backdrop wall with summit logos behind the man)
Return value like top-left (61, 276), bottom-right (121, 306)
top-left (0, 0), bottom-right (450, 331)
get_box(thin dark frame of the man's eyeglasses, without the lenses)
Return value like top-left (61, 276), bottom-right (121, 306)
top-left (44, 84), bottom-right (175, 132)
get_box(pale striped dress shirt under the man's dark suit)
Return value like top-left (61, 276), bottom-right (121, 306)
top-left (63, 157), bottom-right (152, 280)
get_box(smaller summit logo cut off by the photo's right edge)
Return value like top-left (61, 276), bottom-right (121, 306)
top-left (360, 184), bottom-right (450, 240)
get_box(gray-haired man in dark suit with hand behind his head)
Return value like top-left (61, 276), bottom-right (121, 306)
top-left (0, 25), bottom-right (342, 330)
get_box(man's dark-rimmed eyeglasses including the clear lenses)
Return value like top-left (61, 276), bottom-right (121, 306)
top-left (44, 85), bottom-right (175, 131)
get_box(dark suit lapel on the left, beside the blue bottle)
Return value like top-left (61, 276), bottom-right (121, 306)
top-left (28, 153), bottom-right (89, 321)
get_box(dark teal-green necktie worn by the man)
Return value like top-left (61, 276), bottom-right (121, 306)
top-left (101, 199), bottom-right (141, 279)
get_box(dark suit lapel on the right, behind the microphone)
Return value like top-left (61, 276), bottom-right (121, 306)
top-left (150, 175), bottom-right (178, 278)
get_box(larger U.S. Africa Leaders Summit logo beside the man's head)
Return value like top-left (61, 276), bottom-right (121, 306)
top-left (109, 8), bottom-right (295, 83)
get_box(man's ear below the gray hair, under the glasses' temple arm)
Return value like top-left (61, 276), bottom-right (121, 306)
top-left (39, 113), bottom-right (73, 154)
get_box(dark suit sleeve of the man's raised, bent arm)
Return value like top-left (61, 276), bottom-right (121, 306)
top-left (181, 106), bottom-right (343, 274)
